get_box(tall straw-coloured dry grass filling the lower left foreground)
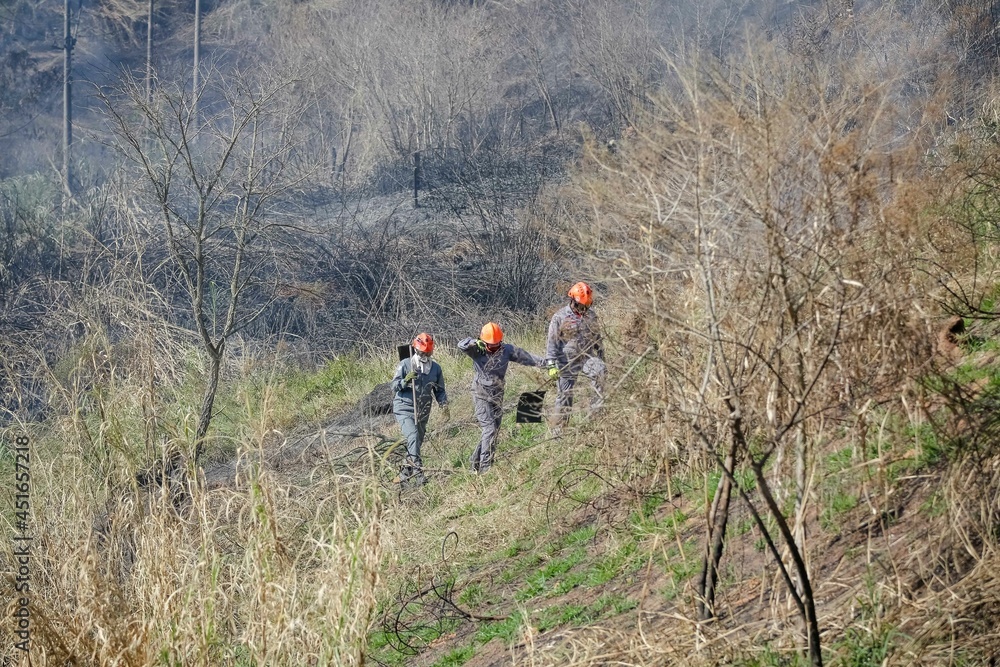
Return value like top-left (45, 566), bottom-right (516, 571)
top-left (0, 328), bottom-right (385, 665)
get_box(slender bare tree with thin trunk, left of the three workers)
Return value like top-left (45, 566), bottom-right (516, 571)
top-left (100, 69), bottom-right (304, 459)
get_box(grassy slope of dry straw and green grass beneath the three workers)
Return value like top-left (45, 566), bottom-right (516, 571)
top-left (2, 314), bottom-right (1000, 665)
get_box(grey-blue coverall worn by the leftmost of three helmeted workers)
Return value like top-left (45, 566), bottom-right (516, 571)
top-left (390, 355), bottom-right (448, 482)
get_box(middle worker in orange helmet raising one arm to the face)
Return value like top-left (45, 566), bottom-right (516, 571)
top-left (458, 322), bottom-right (543, 475)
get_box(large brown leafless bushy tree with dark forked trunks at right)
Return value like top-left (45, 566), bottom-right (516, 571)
top-left (544, 5), bottom-right (968, 666)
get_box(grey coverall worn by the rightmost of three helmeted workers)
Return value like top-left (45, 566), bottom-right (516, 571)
top-left (545, 305), bottom-right (607, 426)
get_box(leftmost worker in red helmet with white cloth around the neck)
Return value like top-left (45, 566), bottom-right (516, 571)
top-left (391, 333), bottom-right (451, 485)
